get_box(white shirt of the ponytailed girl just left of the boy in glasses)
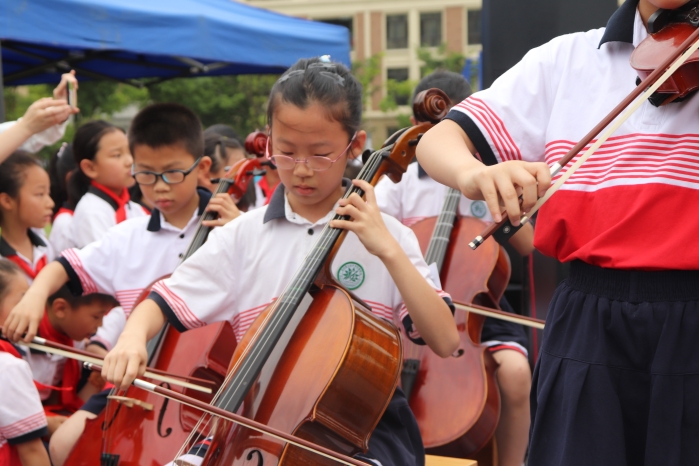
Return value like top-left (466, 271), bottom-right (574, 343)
top-left (71, 186), bottom-right (148, 248)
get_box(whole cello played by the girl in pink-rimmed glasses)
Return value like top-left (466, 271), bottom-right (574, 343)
top-left (167, 88), bottom-right (446, 465)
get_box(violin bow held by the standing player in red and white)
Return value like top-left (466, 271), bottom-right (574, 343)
top-left (469, 28), bottom-right (699, 249)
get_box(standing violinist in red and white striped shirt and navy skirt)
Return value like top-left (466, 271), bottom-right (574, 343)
top-left (418, 0), bottom-right (699, 466)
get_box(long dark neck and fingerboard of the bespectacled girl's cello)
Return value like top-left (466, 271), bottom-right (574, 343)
top-left (216, 146), bottom-right (391, 412)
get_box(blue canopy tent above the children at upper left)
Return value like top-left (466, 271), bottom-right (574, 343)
top-left (0, 0), bottom-right (350, 119)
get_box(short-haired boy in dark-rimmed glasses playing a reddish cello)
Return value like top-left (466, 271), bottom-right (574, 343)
top-left (5, 104), bottom-right (238, 465)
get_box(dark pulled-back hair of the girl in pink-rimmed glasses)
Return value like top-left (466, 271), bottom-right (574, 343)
top-left (267, 57), bottom-right (362, 137)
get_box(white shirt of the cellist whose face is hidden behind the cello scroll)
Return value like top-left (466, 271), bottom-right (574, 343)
top-left (374, 163), bottom-right (493, 227)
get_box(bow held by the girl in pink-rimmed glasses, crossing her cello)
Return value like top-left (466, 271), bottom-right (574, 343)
top-left (85, 363), bottom-right (369, 466)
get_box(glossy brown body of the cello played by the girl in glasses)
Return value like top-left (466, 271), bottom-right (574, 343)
top-left (205, 278), bottom-right (402, 466)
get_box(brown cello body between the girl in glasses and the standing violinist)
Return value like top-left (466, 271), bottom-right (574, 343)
top-left (406, 217), bottom-right (510, 458)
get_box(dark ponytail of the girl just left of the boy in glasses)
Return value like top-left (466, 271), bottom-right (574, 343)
top-left (68, 120), bottom-right (122, 205)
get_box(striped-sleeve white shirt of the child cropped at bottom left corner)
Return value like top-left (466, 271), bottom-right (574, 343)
top-left (0, 351), bottom-right (48, 456)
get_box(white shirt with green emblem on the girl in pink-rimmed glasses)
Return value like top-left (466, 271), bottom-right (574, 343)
top-left (150, 181), bottom-right (451, 341)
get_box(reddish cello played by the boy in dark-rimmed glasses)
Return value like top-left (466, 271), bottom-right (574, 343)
top-left (65, 154), bottom-right (264, 466)
